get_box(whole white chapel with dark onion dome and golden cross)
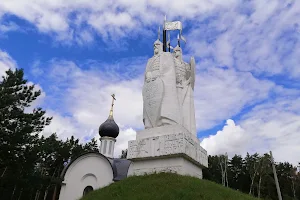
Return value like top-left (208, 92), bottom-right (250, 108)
top-left (59, 95), bottom-right (130, 200)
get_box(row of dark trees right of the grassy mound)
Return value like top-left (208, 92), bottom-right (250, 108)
top-left (203, 153), bottom-right (300, 200)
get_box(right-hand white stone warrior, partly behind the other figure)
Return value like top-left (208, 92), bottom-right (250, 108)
top-left (173, 45), bottom-right (197, 135)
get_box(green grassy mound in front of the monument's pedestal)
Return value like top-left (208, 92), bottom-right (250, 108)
top-left (81, 173), bottom-right (257, 200)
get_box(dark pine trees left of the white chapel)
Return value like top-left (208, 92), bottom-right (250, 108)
top-left (0, 69), bottom-right (98, 200)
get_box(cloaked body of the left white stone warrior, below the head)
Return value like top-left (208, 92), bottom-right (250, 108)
top-left (143, 52), bottom-right (182, 129)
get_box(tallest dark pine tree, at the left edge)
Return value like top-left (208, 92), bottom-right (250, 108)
top-left (0, 69), bottom-right (52, 198)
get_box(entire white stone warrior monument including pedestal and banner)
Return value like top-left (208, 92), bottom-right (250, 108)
top-left (127, 17), bottom-right (208, 178)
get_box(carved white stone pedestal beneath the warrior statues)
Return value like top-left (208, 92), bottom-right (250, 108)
top-left (127, 125), bottom-right (208, 178)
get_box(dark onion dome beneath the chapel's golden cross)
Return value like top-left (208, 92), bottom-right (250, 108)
top-left (99, 115), bottom-right (120, 138)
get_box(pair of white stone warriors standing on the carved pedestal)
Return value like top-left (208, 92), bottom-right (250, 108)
top-left (143, 25), bottom-right (196, 135)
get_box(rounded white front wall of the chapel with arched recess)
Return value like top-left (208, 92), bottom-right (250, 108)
top-left (59, 153), bottom-right (113, 200)
